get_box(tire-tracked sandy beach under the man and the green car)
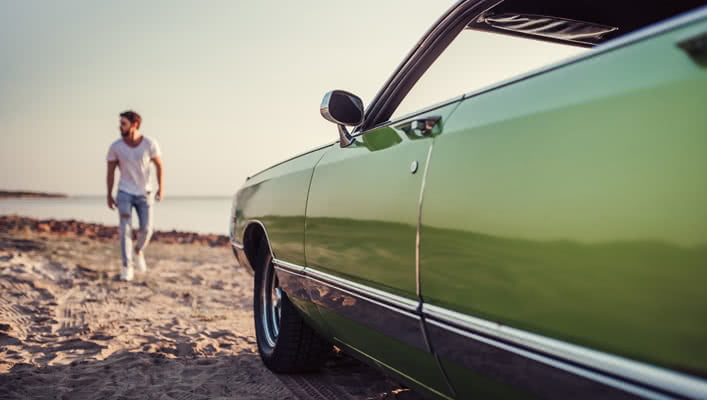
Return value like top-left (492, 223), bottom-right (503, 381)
top-left (0, 218), bottom-right (418, 400)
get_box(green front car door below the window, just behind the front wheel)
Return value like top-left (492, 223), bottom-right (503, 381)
top-left (305, 102), bottom-right (457, 393)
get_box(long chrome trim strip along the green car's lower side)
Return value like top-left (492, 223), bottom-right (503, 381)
top-left (273, 259), bottom-right (707, 399)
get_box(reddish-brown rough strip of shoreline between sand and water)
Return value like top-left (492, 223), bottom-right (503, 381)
top-left (0, 215), bottom-right (230, 247)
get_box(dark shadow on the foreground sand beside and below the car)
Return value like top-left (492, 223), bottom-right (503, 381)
top-left (0, 350), bottom-right (418, 400)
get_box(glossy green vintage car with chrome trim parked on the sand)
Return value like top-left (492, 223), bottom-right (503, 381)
top-left (230, 0), bottom-right (707, 399)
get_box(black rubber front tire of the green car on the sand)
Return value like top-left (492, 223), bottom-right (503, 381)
top-left (253, 244), bottom-right (332, 373)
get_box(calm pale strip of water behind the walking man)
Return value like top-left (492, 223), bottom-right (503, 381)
top-left (0, 195), bottom-right (232, 235)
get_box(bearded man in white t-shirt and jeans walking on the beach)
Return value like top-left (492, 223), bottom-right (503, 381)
top-left (107, 111), bottom-right (164, 281)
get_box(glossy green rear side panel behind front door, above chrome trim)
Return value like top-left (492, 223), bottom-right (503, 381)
top-left (420, 15), bottom-right (707, 376)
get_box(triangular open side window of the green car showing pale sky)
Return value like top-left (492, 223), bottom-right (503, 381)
top-left (391, 30), bottom-right (590, 120)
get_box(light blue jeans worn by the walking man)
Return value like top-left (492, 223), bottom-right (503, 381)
top-left (115, 190), bottom-right (154, 266)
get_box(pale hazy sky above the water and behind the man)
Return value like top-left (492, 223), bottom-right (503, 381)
top-left (0, 0), bottom-right (577, 196)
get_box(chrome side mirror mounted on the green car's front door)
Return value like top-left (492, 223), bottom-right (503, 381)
top-left (319, 90), bottom-right (363, 147)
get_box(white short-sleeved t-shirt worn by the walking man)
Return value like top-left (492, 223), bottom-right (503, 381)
top-left (107, 135), bottom-right (161, 196)
